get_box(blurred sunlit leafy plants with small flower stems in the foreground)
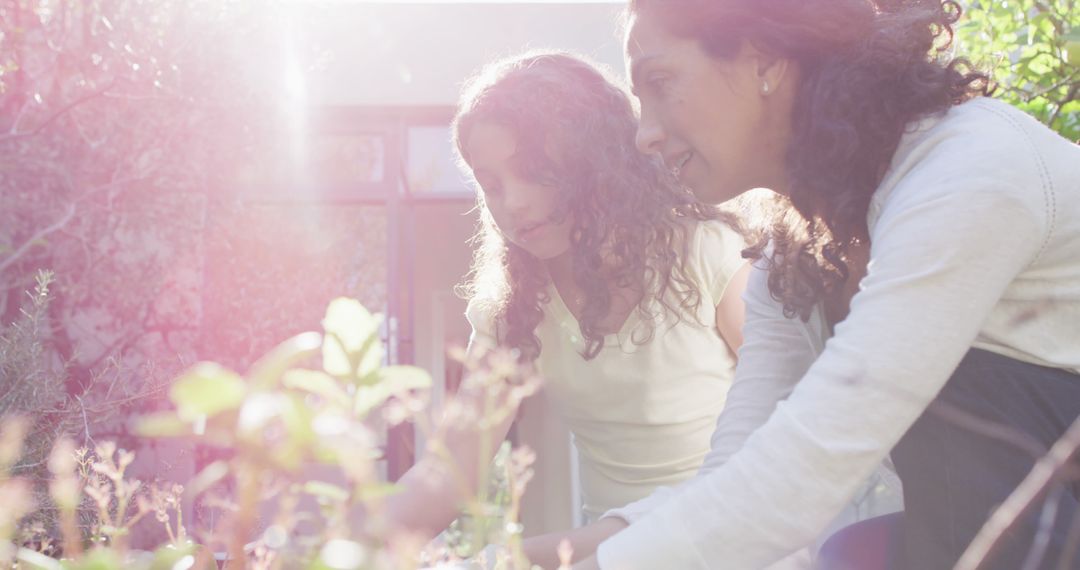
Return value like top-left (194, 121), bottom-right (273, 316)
top-left (0, 299), bottom-right (537, 570)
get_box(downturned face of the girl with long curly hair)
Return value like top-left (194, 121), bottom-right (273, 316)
top-left (464, 122), bottom-right (572, 260)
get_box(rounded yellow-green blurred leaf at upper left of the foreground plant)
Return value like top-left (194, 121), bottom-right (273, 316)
top-left (168, 363), bottom-right (247, 421)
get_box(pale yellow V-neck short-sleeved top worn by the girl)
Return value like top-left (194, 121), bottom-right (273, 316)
top-left (470, 221), bottom-right (745, 520)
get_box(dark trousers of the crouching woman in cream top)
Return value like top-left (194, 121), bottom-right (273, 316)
top-left (819, 349), bottom-right (1080, 570)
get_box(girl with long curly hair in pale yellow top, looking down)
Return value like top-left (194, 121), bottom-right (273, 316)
top-left (390, 53), bottom-right (748, 560)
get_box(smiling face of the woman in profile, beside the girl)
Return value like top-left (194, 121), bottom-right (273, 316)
top-left (626, 9), bottom-right (789, 203)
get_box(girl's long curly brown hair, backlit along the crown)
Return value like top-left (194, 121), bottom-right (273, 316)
top-left (453, 52), bottom-right (738, 359)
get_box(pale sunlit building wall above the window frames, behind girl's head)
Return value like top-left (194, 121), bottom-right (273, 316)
top-left (270, 1), bottom-right (623, 106)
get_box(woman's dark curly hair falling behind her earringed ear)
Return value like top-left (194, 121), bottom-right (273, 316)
top-left (630, 0), bottom-right (993, 320)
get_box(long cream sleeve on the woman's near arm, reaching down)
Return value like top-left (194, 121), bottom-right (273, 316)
top-left (598, 119), bottom-right (1049, 570)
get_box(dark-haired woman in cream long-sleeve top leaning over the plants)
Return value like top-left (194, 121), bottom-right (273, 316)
top-left (578, 0), bottom-right (1080, 570)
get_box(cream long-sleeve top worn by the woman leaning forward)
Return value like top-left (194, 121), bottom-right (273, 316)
top-left (597, 98), bottom-right (1080, 570)
